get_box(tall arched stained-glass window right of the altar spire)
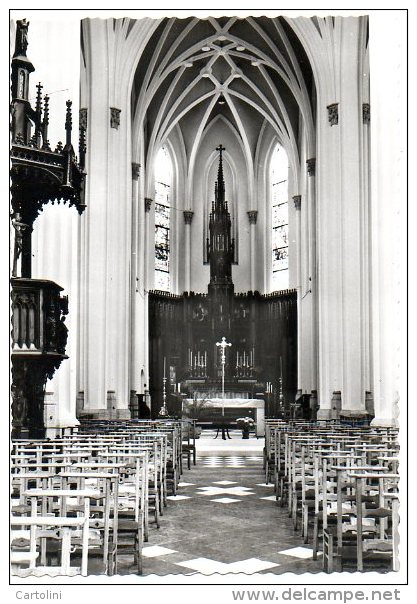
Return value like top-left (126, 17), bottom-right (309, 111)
top-left (270, 145), bottom-right (288, 290)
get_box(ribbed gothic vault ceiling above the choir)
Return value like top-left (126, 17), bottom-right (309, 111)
top-left (128, 17), bottom-right (315, 191)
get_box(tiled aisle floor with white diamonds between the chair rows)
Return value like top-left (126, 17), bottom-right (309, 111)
top-left (115, 439), bottom-right (321, 575)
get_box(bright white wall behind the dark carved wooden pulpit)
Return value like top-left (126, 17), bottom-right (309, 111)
top-left (27, 15), bottom-right (80, 426)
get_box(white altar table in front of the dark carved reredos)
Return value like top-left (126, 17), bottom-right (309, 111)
top-left (182, 398), bottom-right (265, 437)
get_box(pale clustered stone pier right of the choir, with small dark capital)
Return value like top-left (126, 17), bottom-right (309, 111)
top-left (317, 18), bottom-right (366, 417)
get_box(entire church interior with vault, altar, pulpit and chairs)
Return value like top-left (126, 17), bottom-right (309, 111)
top-left (10, 11), bottom-right (404, 578)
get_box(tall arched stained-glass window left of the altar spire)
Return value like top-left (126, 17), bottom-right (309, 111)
top-left (155, 147), bottom-right (172, 291)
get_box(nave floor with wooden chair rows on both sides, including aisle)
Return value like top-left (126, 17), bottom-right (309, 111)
top-left (11, 420), bottom-right (398, 577)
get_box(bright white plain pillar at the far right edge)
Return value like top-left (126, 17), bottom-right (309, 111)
top-left (364, 15), bottom-right (407, 425)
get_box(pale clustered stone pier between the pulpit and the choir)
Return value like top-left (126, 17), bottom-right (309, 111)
top-left (79, 19), bottom-right (132, 417)
